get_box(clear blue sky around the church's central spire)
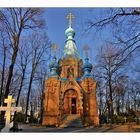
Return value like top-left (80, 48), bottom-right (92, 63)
top-left (44, 8), bottom-right (111, 63)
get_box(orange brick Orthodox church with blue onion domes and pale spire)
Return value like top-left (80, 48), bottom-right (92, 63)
top-left (42, 13), bottom-right (99, 127)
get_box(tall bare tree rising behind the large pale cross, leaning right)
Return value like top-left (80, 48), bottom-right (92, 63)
top-left (0, 8), bottom-right (44, 104)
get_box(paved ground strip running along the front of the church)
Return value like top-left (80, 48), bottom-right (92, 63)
top-left (16, 125), bottom-right (140, 133)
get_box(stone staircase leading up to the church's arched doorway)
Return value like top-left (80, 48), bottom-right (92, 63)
top-left (59, 114), bottom-right (83, 128)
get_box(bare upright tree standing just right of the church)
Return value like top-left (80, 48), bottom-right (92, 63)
top-left (97, 43), bottom-right (126, 123)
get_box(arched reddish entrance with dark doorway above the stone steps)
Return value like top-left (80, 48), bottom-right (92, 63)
top-left (63, 89), bottom-right (79, 114)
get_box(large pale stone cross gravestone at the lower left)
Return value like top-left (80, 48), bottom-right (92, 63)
top-left (0, 96), bottom-right (22, 132)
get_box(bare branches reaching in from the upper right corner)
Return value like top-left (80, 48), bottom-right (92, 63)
top-left (86, 8), bottom-right (140, 59)
